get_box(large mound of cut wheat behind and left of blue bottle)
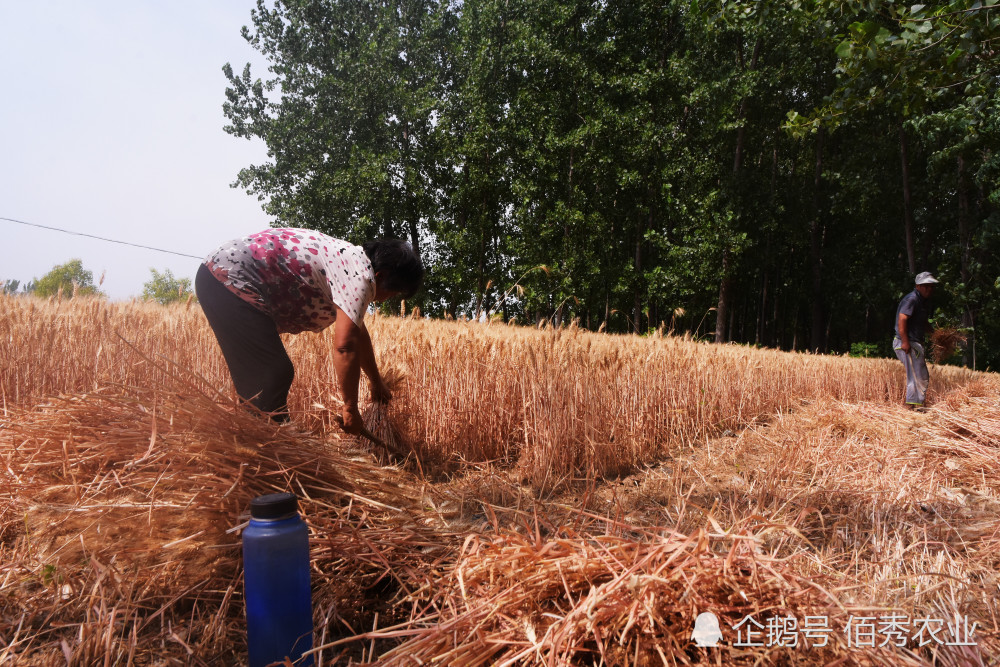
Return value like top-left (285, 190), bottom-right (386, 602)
top-left (0, 368), bottom-right (451, 665)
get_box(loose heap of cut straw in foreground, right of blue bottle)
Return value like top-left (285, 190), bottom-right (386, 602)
top-left (369, 526), bottom-right (840, 667)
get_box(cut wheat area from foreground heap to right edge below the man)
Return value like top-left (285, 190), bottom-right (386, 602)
top-left (330, 382), bottom-right (1000, 666)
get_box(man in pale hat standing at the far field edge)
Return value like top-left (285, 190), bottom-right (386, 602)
top-left (892, 271), bottom-right (938, 410)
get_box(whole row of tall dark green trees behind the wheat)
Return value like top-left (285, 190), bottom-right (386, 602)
top-left (225, 0), bottom-right (1000, 367)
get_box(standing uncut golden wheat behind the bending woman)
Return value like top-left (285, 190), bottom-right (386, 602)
top-left (0, 297), bottom-right (975, 489)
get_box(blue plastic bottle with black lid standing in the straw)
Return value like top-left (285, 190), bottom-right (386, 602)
top-left (243, 493), bottom-right (313, 667)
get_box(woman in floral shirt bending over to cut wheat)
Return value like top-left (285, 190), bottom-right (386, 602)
top-left (195, 228), bottom-right (424, 433)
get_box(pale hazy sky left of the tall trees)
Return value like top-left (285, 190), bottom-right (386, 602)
top-left (0, 0), bottom-right (270, 300)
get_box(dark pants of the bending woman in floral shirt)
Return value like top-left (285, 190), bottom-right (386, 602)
top-left (194, 264), bottom-right (295, 421)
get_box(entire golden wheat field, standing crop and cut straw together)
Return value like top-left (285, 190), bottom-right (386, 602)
top-left (0, 297), bottom-right (1000, 665)
